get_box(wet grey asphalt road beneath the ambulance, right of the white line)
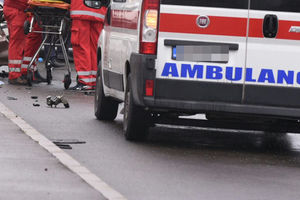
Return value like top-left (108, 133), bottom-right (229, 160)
top-left (0, 66), bottom-right (300, 200)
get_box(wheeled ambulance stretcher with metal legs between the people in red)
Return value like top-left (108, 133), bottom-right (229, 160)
top-left (24, 0), bottom-right (72, 89)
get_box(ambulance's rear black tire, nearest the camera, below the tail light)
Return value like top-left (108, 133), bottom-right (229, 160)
top-left (123, 75), bottom-right (150, 141)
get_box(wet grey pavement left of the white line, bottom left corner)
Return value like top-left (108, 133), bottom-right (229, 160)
top-left (0, 107), bottom-right (104, 200)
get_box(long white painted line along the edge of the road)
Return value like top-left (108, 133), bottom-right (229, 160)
top-left (0, 102), bottom-right (127, 200)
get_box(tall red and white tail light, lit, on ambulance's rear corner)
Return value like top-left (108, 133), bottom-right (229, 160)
top-left (140, 0), bottom-right (159, 54)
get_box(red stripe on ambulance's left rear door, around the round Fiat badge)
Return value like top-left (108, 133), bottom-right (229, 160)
top-left (159, 13), bottom-right (247, 37)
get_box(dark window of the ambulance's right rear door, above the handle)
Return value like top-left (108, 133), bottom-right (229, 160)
top-left (251, 0), bottom-right (300, 13)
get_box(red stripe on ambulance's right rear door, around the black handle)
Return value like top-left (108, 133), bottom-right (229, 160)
top-left (249, 19), bottom-right (300, 40)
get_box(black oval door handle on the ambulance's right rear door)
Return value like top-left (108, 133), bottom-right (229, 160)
top-left (263, 15), bottom-right (278, 38)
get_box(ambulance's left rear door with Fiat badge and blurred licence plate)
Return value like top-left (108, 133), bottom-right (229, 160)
top-left (155, 0), bottom-right (249, 104)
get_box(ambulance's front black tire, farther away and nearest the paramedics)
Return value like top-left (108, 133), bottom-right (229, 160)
top-left (94, 67), bottom-right (119, 121)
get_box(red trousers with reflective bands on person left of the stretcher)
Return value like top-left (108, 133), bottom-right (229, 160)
top-left (4, 6), bottom-right (42, 79)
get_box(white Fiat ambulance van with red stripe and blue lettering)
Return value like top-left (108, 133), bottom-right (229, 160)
top-left (95, 0), bottom-right (300, 140)
